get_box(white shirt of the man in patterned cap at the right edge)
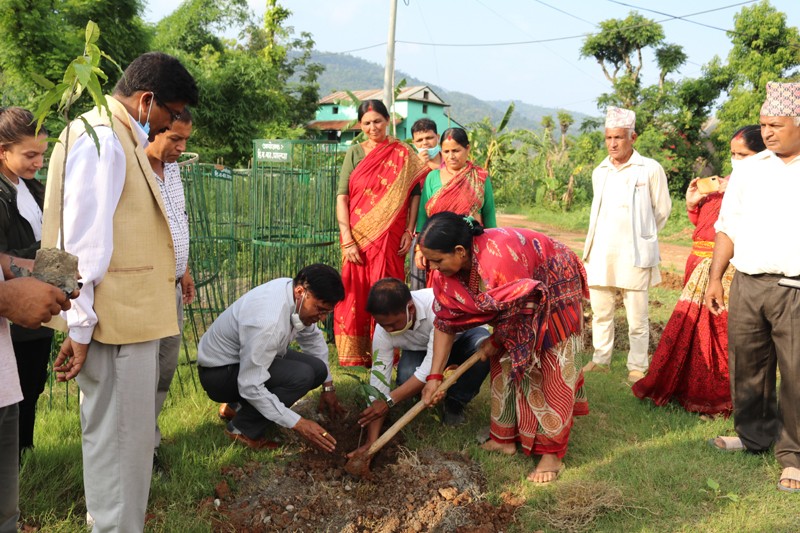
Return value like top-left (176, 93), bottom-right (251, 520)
top-left (714, 150), bottom-right (800, 277)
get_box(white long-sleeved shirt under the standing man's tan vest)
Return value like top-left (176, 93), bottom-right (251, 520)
top-left (59, 118), bottom-right (143, 344)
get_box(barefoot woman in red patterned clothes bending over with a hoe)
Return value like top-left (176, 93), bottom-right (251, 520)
top-left (420, 212), bottom-right (589, 483)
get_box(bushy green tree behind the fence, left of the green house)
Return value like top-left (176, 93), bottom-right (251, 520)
top-left (154, 0), bottom-right (321, 166)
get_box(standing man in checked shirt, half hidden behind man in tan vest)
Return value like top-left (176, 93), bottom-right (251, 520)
top-left (145, 107), bottom-right (195, 472)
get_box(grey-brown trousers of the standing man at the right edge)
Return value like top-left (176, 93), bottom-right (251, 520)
top-left (728, 272), bottom-right (800, 468)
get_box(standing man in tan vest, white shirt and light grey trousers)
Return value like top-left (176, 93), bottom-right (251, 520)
top-left (42, 52), bottom-right (197, 532)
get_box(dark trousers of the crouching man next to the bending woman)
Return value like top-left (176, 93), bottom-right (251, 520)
top-left (397, 327), bottom-right (489, 406)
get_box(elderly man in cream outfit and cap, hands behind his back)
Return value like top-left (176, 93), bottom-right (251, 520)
top-left (583, 107), bottom-right (672, 383)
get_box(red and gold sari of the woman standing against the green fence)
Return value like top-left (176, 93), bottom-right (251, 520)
top-left (333, 138), bottom-right (430, 366)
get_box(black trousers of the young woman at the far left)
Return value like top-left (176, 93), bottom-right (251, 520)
top-left (13, 336), bottom-right (53, 452)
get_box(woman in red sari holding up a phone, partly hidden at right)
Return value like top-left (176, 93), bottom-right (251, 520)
top-left (633, 126), bottom-right (765, 417)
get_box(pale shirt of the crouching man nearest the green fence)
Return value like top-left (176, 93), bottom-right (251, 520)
top-left (197, 278), bottom-right (332, 428)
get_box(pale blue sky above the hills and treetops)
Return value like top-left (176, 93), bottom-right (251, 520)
top-left (145, 0), bottom-right (800, 115)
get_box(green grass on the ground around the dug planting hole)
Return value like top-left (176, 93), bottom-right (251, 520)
top-left (20, 290), bottom-right (800, 533)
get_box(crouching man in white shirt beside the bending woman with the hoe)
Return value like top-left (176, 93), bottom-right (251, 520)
top-left (348, 278), bottom-right (489, 456)
